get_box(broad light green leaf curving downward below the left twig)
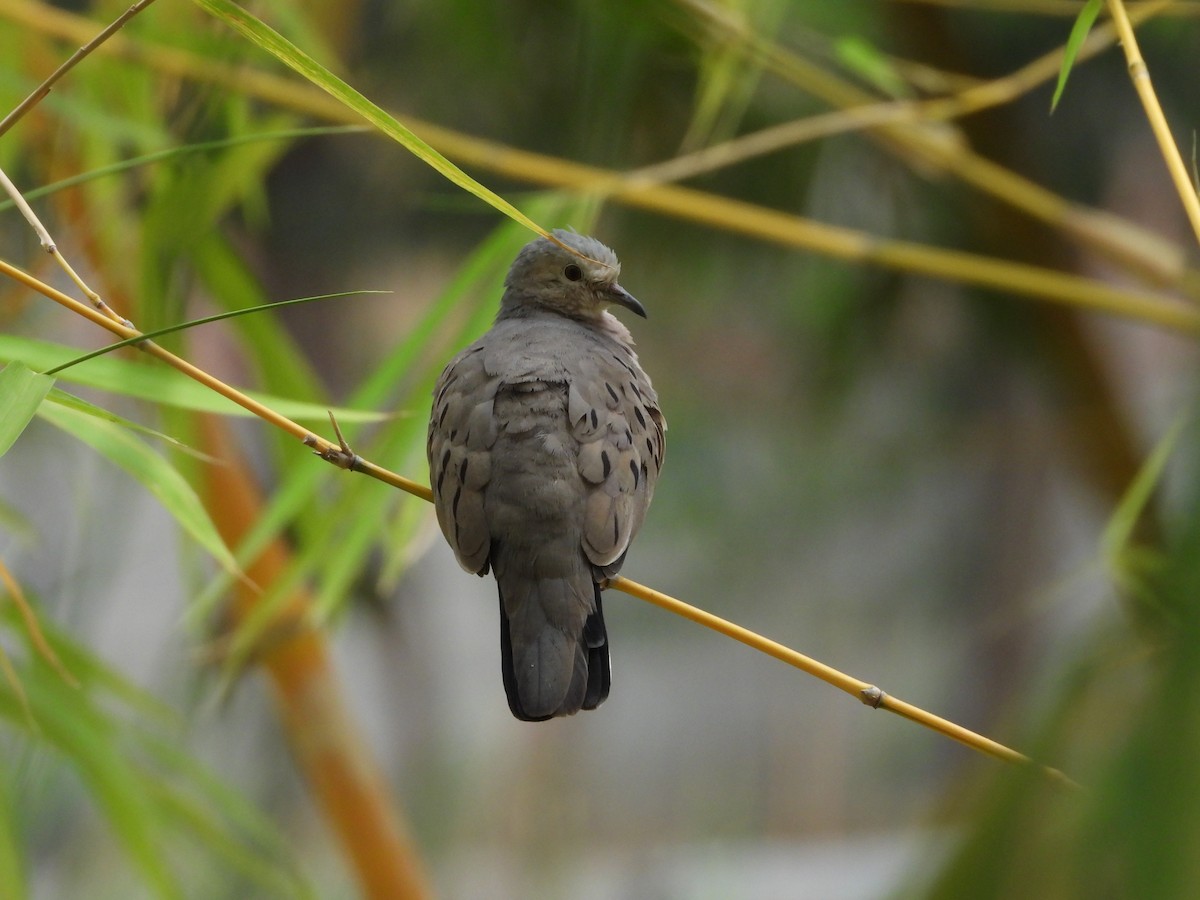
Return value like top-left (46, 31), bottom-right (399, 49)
top-left (38, 403), bottom-right (240, 575)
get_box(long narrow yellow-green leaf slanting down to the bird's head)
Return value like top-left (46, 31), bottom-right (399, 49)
top-left (194, 0), bottom-right (546, 240)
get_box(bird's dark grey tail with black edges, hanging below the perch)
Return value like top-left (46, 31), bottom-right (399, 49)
top-left (497, 578), bottom-right (612, 722)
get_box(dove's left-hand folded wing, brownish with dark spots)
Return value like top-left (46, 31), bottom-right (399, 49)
top-left (426, 342), bottom-right (499, 575)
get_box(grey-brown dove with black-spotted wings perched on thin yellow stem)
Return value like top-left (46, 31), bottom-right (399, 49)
top-left (426, 229), bottom-right (666, 721)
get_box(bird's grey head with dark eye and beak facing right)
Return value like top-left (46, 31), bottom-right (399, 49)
top-left (500, 228), bottom-right (646, 320)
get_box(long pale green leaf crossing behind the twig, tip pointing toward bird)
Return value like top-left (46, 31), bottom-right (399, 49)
top-left (0, 335), bottom-right (386, 422)
